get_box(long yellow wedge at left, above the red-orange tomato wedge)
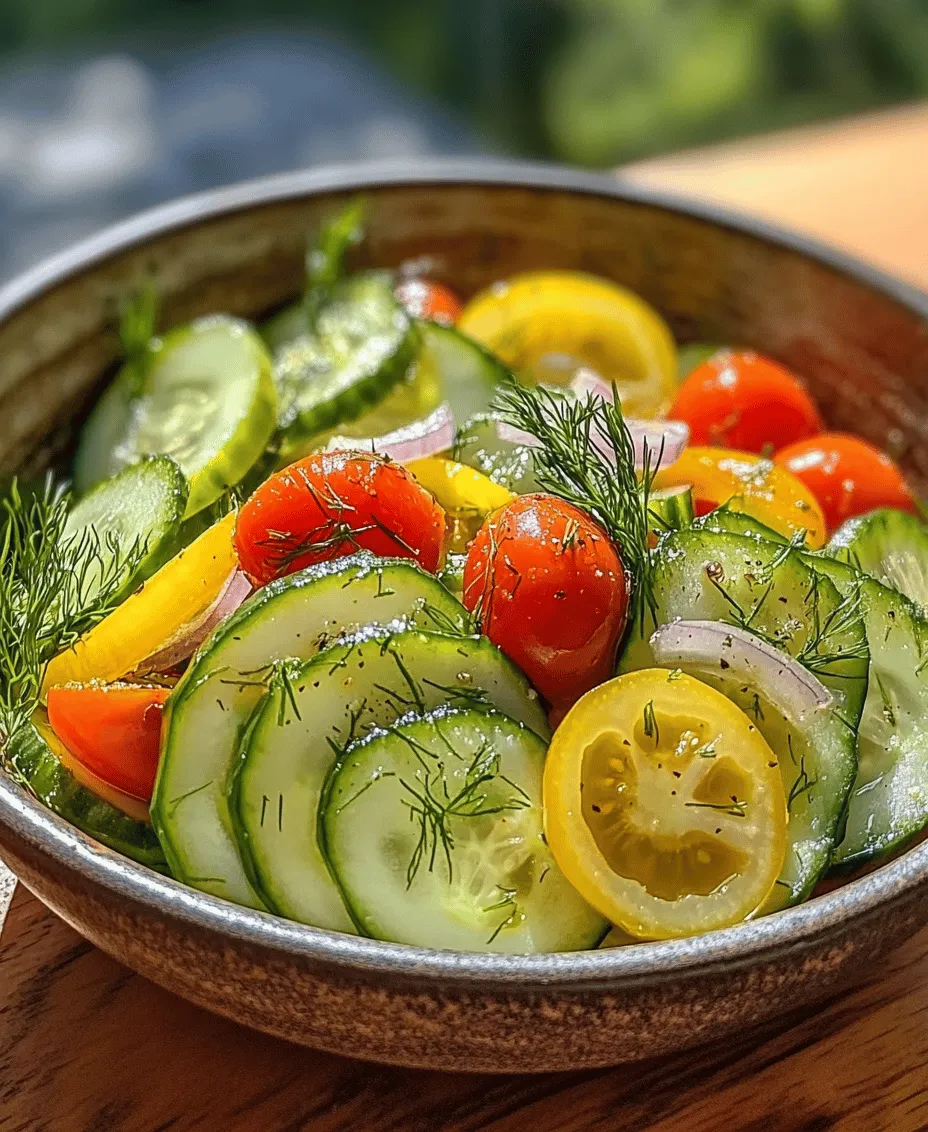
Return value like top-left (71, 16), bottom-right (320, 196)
top-left (43, 513), bottom-right (238, 696)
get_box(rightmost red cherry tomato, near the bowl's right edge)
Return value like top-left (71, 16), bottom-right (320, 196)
top-left (775, 432), bottom-right (916, 531)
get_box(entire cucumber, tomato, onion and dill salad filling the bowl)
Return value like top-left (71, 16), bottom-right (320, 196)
top-left (0, 201), bottom-right (928, 953)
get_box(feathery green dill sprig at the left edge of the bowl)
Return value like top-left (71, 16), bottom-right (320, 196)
top-left (0, 475), bottom-right (146, 744)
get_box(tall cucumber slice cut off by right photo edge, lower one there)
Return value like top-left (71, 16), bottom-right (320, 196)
top-left (807, 555), bottom-right (928, 873)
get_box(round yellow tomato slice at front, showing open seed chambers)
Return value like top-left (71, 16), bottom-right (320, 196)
top-left (544, 669), bottom-right (787, 940)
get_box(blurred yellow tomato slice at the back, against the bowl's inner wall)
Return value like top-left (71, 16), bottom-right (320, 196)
top-left (457, 271), bottom-right (677, 417)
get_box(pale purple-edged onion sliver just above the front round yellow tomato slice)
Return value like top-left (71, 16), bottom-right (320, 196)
top-left (651, 621), bottom-right (833, 723)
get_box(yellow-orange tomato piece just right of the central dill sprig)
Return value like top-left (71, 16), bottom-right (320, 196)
top-left (654, 446), bottom-right (827, 550)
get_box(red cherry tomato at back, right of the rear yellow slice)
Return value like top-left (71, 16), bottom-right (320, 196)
top-left (669, 350), bottom-right (825, 453)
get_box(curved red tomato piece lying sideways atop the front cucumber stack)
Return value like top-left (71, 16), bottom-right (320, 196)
top-left (235, 452), bottom-right (446, 585)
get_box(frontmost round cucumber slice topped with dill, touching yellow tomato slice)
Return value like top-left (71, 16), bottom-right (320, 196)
top-left (320, 709), bottom-right (608, 953)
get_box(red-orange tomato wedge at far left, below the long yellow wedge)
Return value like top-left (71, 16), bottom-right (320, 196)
top-left (48, 684), bottom-right (171, 801)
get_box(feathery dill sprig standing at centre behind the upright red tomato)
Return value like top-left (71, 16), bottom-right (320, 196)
top-left (493, 378), bottom-right (662, 629)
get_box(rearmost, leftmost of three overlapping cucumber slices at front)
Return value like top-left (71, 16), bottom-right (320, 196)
top-left (152, 554), bottom-right (471, 908)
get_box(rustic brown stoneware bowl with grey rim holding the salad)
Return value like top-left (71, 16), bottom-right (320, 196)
top-left (0, 162), bottom-right (928, 1071)
